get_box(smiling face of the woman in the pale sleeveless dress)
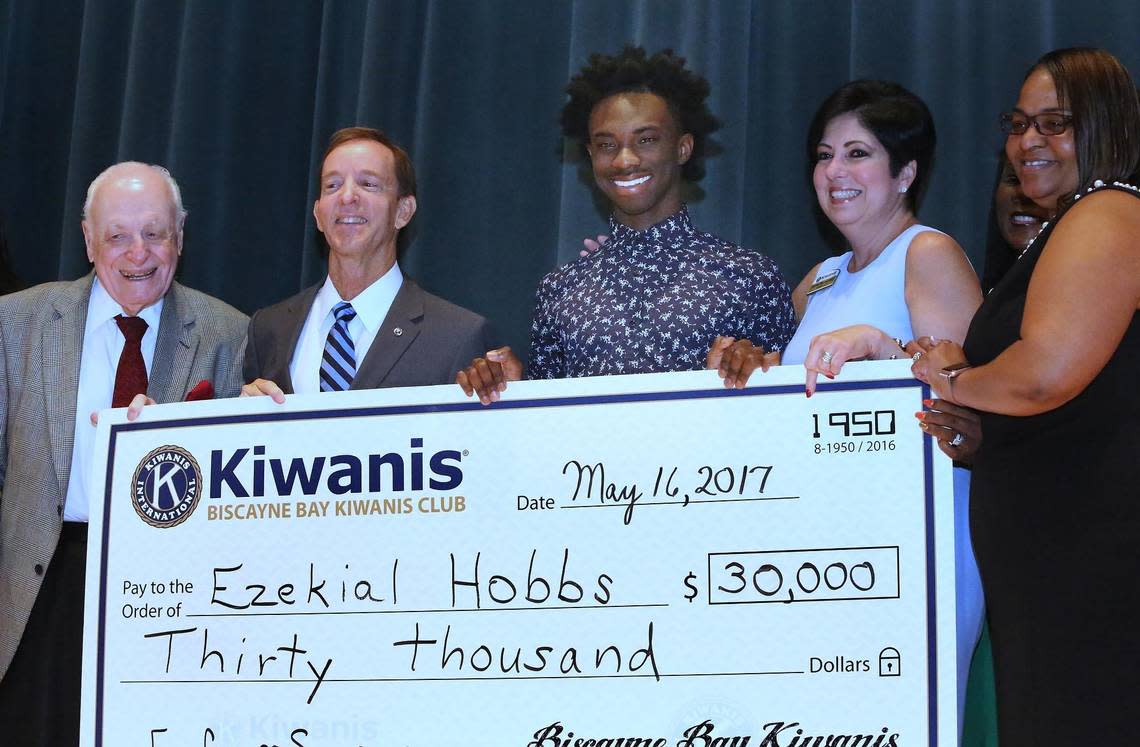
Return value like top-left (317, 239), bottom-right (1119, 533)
top-left (812, 112), bottom-right (915, 239)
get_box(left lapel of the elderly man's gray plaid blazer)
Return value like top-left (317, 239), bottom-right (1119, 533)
top-left (40, 273), bottom-right (95, 495)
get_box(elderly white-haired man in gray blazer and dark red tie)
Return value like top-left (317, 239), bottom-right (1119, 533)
top-left (0, 162), bottom-right (247, 747)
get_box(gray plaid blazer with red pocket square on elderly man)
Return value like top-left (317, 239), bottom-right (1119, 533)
top-left (0, 273), bottom-right (249, 677)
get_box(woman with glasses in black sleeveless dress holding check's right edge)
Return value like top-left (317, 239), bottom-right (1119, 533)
top-left (914, 49), bottom-right (1140, 747)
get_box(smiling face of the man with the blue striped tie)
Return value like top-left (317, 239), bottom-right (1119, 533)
top-left (312, 140), bottom-right (416, 277)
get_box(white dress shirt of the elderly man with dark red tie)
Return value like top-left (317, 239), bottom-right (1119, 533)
top-left (64, 277), bottom-right (162, 521)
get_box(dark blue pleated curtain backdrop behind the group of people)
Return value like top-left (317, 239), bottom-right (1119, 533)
top-left (0, 0), bottom-right (1140, 360)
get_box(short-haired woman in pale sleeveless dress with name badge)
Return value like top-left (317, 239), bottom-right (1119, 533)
top-left (708, 80), bottom-right (984, 725)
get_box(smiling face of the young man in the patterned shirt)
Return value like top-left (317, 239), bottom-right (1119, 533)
top-left (586, 94), bottom-right (693, 230)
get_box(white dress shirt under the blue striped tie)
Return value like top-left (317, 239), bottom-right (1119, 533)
top-left (288, 265), bottom-right (404, 395)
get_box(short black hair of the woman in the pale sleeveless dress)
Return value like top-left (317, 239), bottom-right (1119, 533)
top-left (807, 80), bottom-right (937, 211)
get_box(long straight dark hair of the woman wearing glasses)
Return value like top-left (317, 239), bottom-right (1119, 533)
top-left (1025, 47), bottom-right (1140, 205)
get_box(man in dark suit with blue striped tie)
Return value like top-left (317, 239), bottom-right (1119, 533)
top-left (242, 128), bottom-right (489, 401)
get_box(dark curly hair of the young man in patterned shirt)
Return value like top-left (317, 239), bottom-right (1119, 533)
top-left (562, 44), bottom-right (720, 181)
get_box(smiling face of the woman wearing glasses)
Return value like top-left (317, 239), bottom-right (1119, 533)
top-left (1005, 67), bottom-right (1080, 211)
